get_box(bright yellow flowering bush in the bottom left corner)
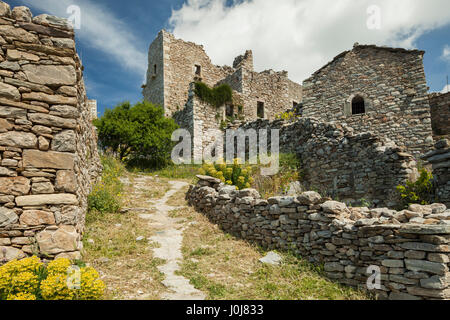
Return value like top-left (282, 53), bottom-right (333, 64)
top-left (0, 257), bottom-right (105, 300)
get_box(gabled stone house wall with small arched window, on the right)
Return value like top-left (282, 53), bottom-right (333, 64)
top-left (303, 45), bottom-right (433, 154)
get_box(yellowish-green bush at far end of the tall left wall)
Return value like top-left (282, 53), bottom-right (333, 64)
top-left (88, 156), bottom-right (125, 213)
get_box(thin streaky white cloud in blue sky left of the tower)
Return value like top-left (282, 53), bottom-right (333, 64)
top-left (22, 0), bottom-right (147, 77)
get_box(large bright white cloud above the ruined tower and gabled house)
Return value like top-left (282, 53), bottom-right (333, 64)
top-left (169, 0), bottom-right (450, 82)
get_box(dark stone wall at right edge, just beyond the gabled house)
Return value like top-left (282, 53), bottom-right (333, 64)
top-left (429, 92), bottom-right (450, 136)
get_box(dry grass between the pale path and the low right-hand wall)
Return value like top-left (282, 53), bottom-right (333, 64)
top-left (176, 208), bottom-right (369, 300)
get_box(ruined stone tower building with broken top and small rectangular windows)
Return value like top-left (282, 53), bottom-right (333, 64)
top-left (143, 30), bottom-right (302, 120)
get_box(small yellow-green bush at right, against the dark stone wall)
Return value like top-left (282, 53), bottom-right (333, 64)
top-left (397, 168), bottom-right (434, 208)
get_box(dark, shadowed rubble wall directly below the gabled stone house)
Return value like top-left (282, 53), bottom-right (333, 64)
top-left (230, 118), bottom-right (416, 206)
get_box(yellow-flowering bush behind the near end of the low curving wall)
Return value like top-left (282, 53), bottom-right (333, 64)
top-left (199, 159), bottom-right (253, 190)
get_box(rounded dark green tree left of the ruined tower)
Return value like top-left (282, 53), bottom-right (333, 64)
top-left (94, 101), bottom-right (178, 168)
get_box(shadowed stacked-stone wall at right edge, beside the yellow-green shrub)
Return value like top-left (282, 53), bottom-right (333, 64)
top-left (423, 139), bottom-right (450, 207)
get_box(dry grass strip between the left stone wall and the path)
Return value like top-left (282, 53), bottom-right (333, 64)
top-left (83, 172), bottom-right (164, 300)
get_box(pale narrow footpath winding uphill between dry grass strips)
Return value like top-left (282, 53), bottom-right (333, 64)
top-left (136, 176), bottom-right (205, 300)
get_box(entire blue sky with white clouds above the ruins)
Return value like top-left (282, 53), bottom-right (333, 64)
top-left (6, 0), bottom-right (450, 113)
